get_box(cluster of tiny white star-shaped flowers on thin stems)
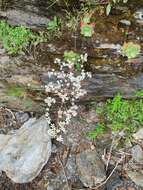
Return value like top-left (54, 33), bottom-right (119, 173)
top-left (45, 54), bottom-right (91, 141)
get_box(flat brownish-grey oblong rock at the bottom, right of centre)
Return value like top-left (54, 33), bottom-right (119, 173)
top-left (76, 150), bottom-right (106, 187)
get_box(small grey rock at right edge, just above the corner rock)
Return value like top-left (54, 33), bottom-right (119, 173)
top-left (132, 145), bottom-right (143, 164)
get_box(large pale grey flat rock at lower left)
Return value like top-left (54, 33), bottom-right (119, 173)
top-left (0, 117), bottom-right (51, 183)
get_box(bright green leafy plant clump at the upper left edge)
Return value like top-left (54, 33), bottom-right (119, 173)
top-left (0, 21), bottom-right (39, 54)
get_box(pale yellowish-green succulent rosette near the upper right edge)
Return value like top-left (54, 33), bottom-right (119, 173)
top-left (121, 42), bottom-right (141, 59)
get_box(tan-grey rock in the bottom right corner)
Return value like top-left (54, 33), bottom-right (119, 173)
top-left (128, 171), bottom-right (143, 187)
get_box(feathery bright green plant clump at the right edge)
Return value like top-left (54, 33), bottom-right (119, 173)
top-left (87, 94), bottom-right (143, 140)
